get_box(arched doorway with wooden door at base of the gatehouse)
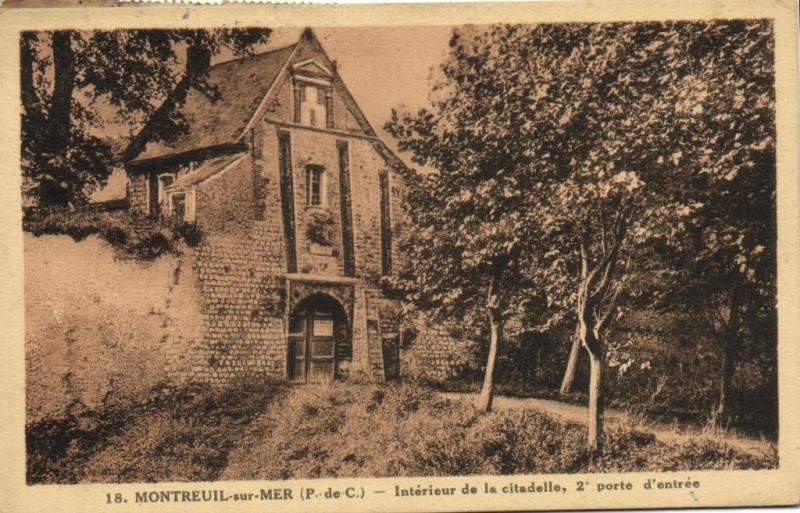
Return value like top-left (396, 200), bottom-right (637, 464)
top-left (288, 294), bottom-right (353, 383)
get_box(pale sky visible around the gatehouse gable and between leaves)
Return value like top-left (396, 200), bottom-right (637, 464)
top-left (92, 26), bottom-right (453, 201)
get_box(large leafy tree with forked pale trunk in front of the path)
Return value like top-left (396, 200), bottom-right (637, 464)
top-left (541, 21), bottom-right (774, 450)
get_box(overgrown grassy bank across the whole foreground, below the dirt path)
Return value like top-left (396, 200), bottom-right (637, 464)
top-left (27, 382), bottom-right (777, 483)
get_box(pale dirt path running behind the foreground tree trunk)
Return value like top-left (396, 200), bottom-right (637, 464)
top-left (442, 393), bottom-right (772, 455)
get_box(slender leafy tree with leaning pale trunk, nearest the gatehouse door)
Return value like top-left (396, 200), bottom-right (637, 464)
top-left (386, 29), bottom-right (552, 411)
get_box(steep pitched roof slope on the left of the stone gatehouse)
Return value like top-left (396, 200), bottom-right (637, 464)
top-left (134, 45), bottom-right (296, 160)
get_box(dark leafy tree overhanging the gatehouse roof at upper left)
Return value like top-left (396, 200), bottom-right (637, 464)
top-left (20, 28), bottom-right (270, 206)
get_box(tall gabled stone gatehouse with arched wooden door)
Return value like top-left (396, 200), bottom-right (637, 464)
top-left (126, 29), bottom-right (472, 383)
